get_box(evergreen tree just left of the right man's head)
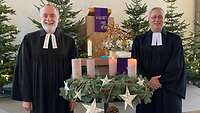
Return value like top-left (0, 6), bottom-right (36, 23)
top-left (122, 0), bottom-right (149, 38)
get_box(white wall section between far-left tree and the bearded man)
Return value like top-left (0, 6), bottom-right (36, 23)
top-left (5, 0), bottom-right (40, 43)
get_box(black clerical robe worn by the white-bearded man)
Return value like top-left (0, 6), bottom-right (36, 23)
top-left (12, 29), bottom-right (76, 113)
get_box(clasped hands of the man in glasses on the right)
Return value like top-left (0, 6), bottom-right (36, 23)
top-left (149, 76), bottom-right (161, 90)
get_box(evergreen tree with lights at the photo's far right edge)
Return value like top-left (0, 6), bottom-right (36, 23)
top-left (185, 23), bottom-right (200, 87)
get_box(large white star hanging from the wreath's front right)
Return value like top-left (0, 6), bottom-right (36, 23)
top-left (119, 87), bottom-right (136, 110)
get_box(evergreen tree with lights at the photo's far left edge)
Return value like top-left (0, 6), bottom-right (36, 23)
top-left (0, 0), bottom-right (19, 85)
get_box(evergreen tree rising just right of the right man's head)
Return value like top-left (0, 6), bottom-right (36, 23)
top-left (164, 0), bottom-right (189, 38)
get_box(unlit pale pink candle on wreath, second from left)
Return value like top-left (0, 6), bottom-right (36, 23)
top-left (87, 59), bottom-right (95, 78)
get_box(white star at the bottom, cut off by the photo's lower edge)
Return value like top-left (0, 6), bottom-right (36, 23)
top-left (82, 99), bottom-right (104, 113)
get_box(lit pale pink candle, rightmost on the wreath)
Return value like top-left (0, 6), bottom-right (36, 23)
top-left (128, 59), bottom-right (137, 77)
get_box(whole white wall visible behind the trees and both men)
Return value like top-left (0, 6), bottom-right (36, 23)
top-left (6, 0), bottom-right (194, 42)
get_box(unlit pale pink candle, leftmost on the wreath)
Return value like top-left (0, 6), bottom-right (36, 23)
top-left (72, 59), bottom-right (82, 79)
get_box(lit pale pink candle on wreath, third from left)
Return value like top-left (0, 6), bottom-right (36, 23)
top-left (108, 57), bottom-right (117, 76)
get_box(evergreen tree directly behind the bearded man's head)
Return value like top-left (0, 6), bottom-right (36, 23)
top-left (30, 0), bottom-right (87, 57)
